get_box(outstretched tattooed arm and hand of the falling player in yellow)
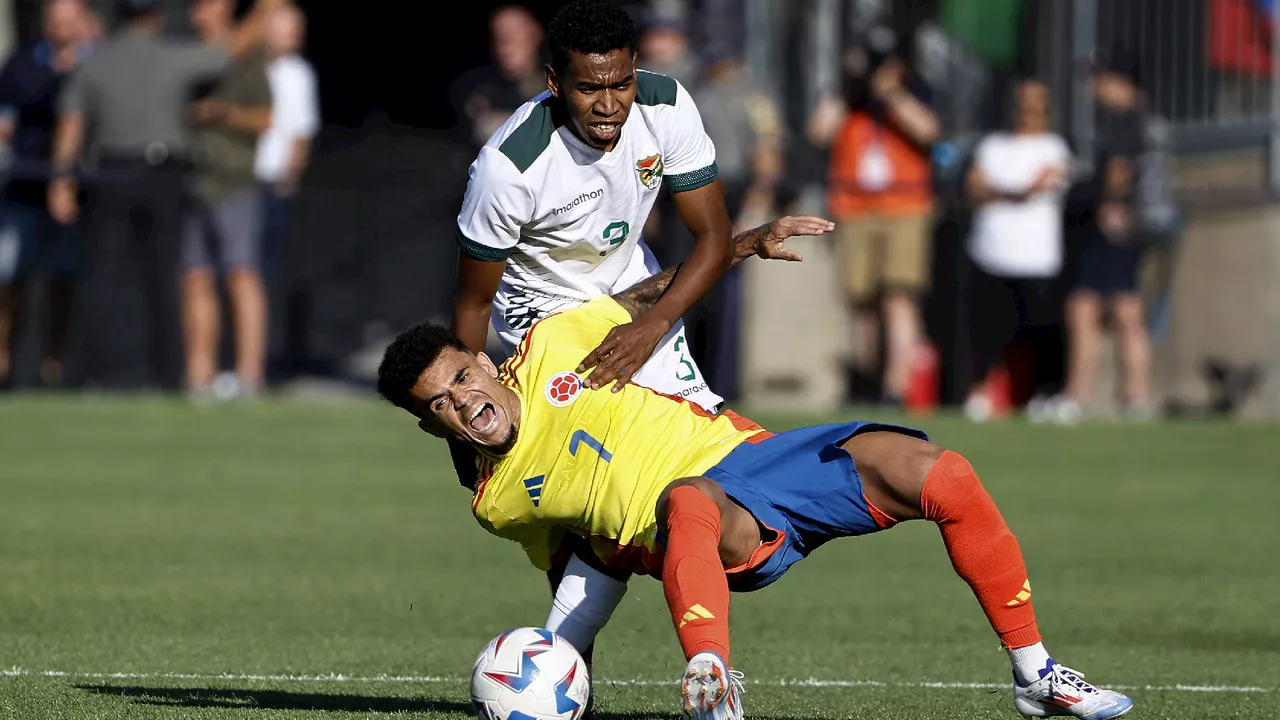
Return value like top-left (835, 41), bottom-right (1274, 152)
top-left (601, 215), bottom-right (836, 322)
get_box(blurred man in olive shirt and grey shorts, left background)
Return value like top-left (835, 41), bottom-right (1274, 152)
top-left (182, 0), bottom-right (273, 400)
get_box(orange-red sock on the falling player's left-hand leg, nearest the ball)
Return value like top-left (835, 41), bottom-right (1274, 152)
top-left (662, 487), bottom-right (728, 664)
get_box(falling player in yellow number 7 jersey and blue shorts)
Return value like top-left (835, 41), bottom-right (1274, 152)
top-left (378, 217), bottom-right (1133, 720)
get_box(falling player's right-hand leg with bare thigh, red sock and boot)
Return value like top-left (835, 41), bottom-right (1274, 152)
top-left (842, 432), bottom-right (1133, 720)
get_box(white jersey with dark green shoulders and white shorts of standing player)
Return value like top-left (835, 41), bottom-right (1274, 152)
top-left (457, 70), bottom-right (721, 410)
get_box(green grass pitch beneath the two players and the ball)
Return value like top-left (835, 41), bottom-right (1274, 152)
top-left (0, 397), bottom-right (1280, 720)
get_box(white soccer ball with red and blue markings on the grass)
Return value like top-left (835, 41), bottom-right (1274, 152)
top-left (471, 628), bottom-right (591, 720)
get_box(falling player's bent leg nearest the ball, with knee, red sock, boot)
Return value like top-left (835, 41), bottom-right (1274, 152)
top-left (658, 478), bottom-right (760, 719)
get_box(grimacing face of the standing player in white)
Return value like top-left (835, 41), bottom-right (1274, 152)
top-left (547, 47), bottom-right (636, 151)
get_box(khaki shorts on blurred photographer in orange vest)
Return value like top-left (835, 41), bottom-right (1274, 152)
top-left (836, 213), bottom-right (933, 302)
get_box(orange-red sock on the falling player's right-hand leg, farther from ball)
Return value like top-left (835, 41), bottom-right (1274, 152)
top-left (920, 451), bottom-right (1041, 650)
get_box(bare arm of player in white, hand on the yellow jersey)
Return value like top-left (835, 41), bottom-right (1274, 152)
top-left (582, 181), bottom-right (733, 392)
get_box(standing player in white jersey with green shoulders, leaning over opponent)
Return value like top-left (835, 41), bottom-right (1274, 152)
top-left (451, 0), bottom-right (732, 413)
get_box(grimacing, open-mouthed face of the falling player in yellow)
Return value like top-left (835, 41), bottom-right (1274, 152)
top-left (411, 347), bottom-right (520, 455)
